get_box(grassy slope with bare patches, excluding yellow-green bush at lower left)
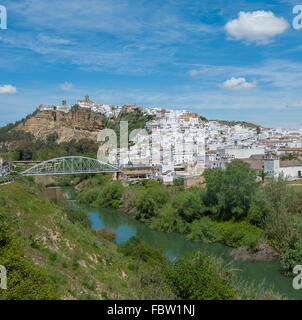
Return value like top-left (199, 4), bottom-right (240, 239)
top-left (0, 182), bottom-right (169, 299)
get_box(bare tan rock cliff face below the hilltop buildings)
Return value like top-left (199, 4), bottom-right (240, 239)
top-left (14, 107), bottom-right (105, 143)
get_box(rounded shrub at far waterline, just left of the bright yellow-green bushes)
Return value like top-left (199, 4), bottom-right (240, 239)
top-left (187, 217), bottom-right (219, 242)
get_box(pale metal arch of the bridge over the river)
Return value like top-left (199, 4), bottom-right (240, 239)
top-left (21, 156), bottom-right (123, 176)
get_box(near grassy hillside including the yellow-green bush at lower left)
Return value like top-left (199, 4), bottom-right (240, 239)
top-left (0, 180), bottom-right (173, 300)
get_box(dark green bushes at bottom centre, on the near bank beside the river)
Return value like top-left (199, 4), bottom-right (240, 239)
top-left (119, 237), bottom-right (237, 300)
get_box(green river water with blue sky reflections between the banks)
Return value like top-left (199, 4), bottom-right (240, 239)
top-left (81, 206), bottom-right (302, 299)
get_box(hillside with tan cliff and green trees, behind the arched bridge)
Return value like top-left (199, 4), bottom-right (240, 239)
top-left (0, 105), bottom-right (153, 160)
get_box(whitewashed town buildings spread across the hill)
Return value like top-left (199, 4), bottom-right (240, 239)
top-left (33, 95), bottom-right (302, 181)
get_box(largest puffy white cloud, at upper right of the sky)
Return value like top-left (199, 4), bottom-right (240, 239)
top-left (225, 10), bottom-right (289, 43)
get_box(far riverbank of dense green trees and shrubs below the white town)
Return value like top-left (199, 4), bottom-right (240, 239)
top-left (72, 160), bottom-right (302, 290)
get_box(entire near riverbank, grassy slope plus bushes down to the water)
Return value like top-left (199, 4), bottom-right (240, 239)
top-left (0, 178), bottom-right (281, 300)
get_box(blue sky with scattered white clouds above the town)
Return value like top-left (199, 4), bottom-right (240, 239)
top-left (0, 0), bottom-right (302, 127)
